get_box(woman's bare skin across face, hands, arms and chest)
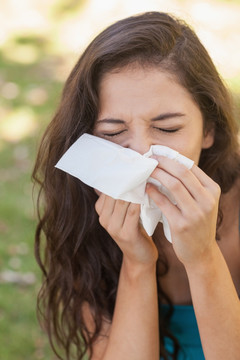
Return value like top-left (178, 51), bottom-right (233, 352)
top-left (85, 66), bottom-right (240, 360)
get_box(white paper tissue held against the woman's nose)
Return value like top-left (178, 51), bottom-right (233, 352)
top-left (56, 134), bottom-right (194, 242)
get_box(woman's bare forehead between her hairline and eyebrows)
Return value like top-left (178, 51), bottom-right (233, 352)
top-left (99, 66), bottom-right (197, 112)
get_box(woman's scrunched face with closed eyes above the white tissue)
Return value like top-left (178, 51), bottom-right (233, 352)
top-left (93, 66), bottom-right (213, 164)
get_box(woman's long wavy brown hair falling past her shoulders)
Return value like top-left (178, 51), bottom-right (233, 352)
top-left (33, 12), bottom-right (240, 360)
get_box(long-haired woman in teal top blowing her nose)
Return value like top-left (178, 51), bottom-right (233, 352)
top-left (33, 12), bottom-right (240, 360)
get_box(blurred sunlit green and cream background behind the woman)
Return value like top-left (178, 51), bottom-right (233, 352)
top-left (0, 0), bottom-right (240, 360)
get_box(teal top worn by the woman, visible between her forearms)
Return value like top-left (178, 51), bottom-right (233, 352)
top-left (160, 211), bottom-right (240, 360)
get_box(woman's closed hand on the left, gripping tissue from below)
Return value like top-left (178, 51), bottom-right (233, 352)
top-left (95, 194), bottom-right (158, 266)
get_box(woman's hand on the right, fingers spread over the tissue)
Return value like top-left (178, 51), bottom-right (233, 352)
top-left (146, 156), bottom-right (220, 266)
